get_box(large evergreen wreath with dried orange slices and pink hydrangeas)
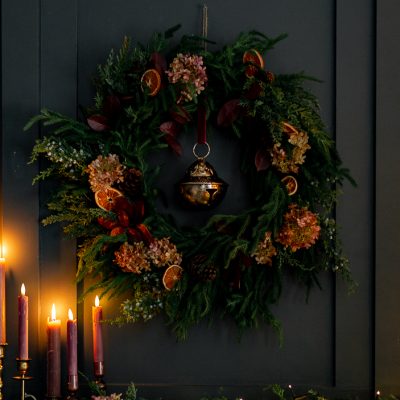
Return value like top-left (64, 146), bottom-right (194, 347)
top-left (26, 28), bottom-right (351, 338)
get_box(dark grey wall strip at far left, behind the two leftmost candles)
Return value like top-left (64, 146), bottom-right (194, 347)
top-left (1, 0), bottom-right (42, 398)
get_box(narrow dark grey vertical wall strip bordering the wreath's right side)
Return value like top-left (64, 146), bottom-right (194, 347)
top-left (336, 0), bottom-right (375, 390)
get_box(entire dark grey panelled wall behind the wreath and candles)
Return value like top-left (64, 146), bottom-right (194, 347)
top-left (1, 0), bottom-right (400, 399)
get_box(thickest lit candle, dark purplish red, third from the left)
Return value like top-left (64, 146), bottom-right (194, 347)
top-left (47, 304), bottom-right (61, 397)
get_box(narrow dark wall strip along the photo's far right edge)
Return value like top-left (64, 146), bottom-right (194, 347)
top-left (375, 0), bottom-right (400, 394)
